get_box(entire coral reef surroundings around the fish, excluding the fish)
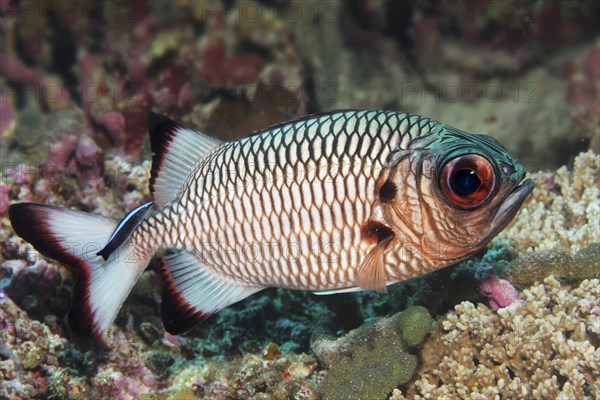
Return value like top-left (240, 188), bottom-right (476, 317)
top-left (0, 0), bottom-right (600, 400)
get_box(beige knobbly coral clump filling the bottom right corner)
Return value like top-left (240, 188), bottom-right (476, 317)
top-left (390, 276), bottom-right (600, 400)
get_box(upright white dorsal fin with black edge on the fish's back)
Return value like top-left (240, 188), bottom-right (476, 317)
top-left (148, 112), bottom-right (222, 206)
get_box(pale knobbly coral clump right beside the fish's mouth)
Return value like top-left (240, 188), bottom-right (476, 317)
top-left (499, 151), bottom-right (600, 252)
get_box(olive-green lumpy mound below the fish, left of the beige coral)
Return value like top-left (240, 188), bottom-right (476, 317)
top-left (313, 306), bottom-right (433, 400)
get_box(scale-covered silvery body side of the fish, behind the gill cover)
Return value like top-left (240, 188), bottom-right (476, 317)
top-left (155, 111), bottom-right (432, 290)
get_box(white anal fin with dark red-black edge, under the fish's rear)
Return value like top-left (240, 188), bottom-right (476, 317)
top-left (160, 253), bottom-right (263, 335)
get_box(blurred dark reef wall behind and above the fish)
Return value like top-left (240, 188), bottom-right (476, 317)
top-left (0, 0), bottom-right (599, 169)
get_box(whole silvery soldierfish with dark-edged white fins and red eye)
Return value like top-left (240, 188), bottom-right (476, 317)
top-left (9, 111), bottom-right (533, 339)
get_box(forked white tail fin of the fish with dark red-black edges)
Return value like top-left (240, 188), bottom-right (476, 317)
top-left (8, 203), bottom-right (148, 342)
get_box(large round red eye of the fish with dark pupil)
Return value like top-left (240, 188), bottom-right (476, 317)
top-left (440, 154), bottom-right (496, 208)
